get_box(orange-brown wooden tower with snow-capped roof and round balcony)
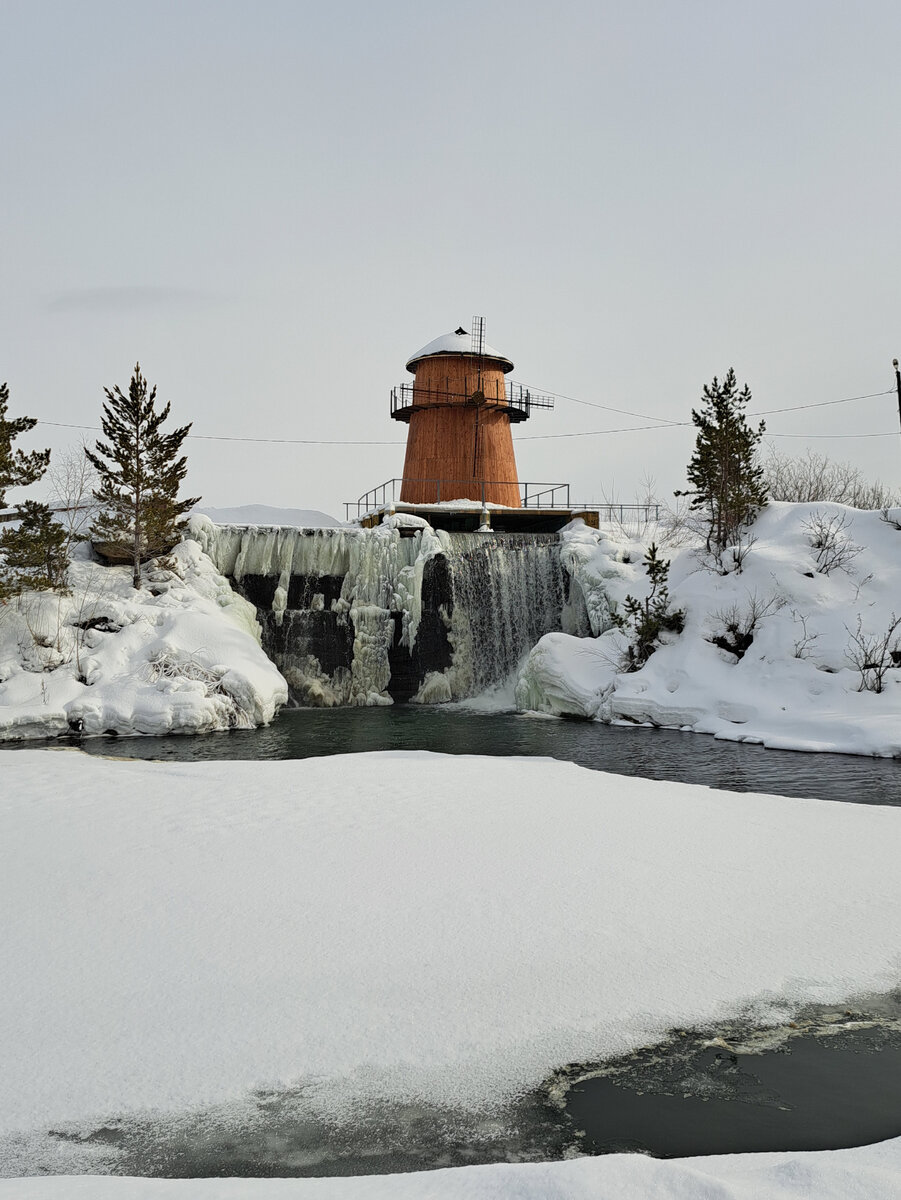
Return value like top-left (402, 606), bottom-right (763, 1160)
top-left (391, 318), bottom-right (530, 509)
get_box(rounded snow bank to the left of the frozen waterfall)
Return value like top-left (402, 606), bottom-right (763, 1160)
top-left (0, 541), bottom-right (287, 739)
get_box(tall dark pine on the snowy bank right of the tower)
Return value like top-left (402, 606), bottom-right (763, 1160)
top-left (675, 368), bottom-right (767, 551)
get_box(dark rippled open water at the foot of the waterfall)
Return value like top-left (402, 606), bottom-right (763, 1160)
top-left (52, 704), bottom-right (901, 804)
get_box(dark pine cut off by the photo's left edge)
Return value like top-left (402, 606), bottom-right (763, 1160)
top-left (0, 383), bottom-right (66, 599)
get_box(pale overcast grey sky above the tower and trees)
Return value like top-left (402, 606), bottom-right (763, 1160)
top-left (0, 0), bottom-right (901, 515)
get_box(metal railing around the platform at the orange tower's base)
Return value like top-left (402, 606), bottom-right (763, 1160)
top-left (344, 478), bottom-right (660, 524)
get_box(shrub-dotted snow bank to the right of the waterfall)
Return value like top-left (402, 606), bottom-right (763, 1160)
top-left (517, 504), bottom-right (901, 755)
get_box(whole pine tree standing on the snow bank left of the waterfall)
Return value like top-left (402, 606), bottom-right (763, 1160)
top-left (85, 362), bottom-right (199, 588)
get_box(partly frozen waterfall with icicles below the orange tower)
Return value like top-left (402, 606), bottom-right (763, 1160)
top-left (192, 517), bottom-right (589, 706)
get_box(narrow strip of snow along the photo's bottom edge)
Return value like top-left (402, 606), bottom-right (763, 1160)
top-left (0, 1139), bottom-right (901, 1200)
